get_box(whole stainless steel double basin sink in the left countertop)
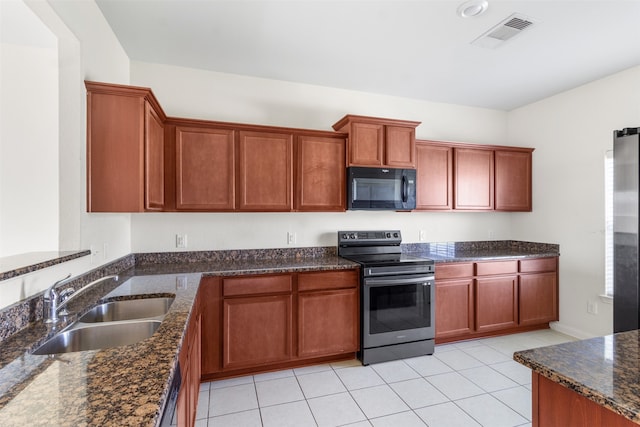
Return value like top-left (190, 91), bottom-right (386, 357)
top-left (33, 298), bottom-right (174, 355)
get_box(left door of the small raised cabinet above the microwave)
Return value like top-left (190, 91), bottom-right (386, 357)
top-left (349, 123), bottom-right (384, 166)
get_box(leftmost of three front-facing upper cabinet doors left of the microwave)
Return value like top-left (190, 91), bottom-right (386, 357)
top-left (176, 127), bottom-right (236, 211)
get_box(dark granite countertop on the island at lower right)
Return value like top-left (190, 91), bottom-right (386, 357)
top-left (513, 330), bottom-right (640, 424)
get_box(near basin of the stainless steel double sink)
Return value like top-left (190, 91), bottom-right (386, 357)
top-left (33, 320), bottom-right (162, 355)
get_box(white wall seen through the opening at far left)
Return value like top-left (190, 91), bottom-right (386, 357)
top-left (0, 0), bottom-right (59, 257)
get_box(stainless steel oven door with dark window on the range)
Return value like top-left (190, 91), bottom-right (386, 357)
top-left (362, 275), bottom-right (435, 348)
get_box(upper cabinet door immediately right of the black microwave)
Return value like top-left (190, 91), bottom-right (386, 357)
top-left (416, 142), bottom-right (453, 210)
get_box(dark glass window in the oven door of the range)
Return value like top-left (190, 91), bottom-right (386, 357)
top-left (369, 283), bottom-right (431, 335)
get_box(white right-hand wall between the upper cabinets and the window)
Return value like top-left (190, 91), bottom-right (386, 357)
top-left (508, 67), bottom-right (640, 337)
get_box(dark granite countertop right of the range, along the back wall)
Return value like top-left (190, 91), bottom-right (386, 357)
top-left (402, 240), bottom-right (560, 263)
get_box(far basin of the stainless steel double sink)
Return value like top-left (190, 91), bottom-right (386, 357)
top-left (80, 298), bottom-right (173, 323)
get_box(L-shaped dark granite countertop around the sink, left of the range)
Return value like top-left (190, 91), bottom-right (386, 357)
top-left (0, 253), bottom-right (357, 427)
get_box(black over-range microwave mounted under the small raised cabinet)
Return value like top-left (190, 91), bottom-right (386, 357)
top-left (347, 167), bottom-right (416, 210)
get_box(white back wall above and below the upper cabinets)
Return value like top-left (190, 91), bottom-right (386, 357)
top-left (131, 61), bottom-right (526, 252)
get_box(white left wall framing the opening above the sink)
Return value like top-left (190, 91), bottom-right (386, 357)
top-left (0, 0), bottom-right (131, 308)
